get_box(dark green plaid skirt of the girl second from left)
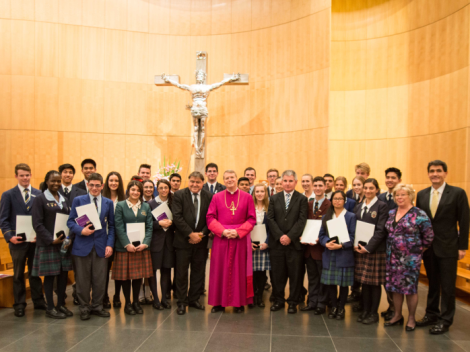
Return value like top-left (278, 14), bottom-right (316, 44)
top-left (31, 245), bottom-right (72, 276)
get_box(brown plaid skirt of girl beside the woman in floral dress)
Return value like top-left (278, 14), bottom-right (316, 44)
top-left (354, 252), bottom-right (386, 286)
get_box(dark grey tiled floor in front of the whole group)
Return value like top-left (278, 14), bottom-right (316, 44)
top-left (0, 270), bottom-right (470, 352)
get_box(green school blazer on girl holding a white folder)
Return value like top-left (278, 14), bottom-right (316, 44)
top-left (114, 200), bottom-right (153, 252)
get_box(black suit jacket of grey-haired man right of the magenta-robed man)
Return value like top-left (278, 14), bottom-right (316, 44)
top-left (268, 190), bottom-right (308, 250)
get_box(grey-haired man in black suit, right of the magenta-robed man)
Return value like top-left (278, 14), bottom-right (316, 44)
top-left (268, 170), bottom-right (308, 314)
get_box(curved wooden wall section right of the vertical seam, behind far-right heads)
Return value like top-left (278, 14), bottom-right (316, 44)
top-left (329, 0), bottom-right (470, 191)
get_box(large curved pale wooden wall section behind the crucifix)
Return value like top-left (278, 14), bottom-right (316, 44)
top-left (0, 0), bottom-right (330, 190)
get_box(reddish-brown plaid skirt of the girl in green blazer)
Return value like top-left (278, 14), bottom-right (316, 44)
top-left (112, 250), bottom-right (153, 281)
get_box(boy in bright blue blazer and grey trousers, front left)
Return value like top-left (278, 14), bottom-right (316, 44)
top-left (67, 173), bottom-right (114, 320)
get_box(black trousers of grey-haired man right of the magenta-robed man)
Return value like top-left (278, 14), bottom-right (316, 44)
top-left (269, 247), bottom-right (304, 305)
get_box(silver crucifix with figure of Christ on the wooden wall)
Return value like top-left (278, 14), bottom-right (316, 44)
top-left (155, 51), bottom-right (248, 164)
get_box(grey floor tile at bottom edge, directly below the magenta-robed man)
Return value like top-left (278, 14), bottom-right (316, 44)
top-left (205, 333), bottom-right (270, 352)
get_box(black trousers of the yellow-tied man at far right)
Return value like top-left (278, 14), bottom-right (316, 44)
top-left (423, 248), bottom-right (458, 326)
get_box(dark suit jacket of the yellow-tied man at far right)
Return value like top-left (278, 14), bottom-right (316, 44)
top-left (416, 184), bottom-right (470, 258)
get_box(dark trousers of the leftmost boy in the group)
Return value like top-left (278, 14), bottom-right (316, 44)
top-left (10, 243), bottom-right (46, 309)
